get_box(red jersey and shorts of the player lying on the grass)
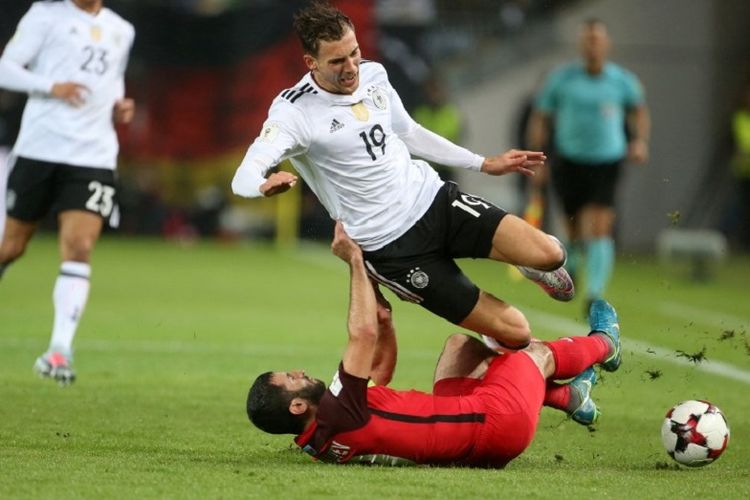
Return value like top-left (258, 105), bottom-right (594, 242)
top-left (295, 355), bottom-right (544, 466)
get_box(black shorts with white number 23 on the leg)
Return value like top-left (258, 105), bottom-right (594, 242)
top-left (6, 157), bottom-right (118, 226)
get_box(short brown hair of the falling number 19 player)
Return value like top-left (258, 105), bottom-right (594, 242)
top-left (292, 0), bottom-right (354, 56)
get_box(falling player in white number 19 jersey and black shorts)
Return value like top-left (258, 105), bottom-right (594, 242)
top-left (232, 2), bottom-right (573, 349)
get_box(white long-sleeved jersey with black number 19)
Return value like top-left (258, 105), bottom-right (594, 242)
top-left (232, 61), bottom-right (483, 251)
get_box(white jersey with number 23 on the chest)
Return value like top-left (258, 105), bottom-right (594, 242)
top-left (0, 0), bottom-right (135, 169)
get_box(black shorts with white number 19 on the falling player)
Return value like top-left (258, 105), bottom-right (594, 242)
top-left (364, 182), bottom-right (507, 324)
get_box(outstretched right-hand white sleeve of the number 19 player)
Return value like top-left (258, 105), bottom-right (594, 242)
top-left (389, 79), bottom-right (484, 171)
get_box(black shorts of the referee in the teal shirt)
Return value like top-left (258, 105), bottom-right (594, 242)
top-left (551, 157), bottom-right (622, 217)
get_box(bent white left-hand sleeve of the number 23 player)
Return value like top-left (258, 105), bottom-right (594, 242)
top-left (0, 5), bottom-right (55, 94)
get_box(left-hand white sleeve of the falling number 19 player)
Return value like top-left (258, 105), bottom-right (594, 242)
top-left (232, 104), bottom-right (310, 198)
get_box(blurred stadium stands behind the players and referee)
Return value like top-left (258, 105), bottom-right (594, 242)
top-left (0, 0), bottom-right (750, 251)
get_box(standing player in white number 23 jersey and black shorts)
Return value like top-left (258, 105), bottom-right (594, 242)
top-left (0, 0), bottom-right (135, 384)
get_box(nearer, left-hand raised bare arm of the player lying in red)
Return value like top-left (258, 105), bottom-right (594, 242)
top-left (331, 222), bottom-right (378, 378)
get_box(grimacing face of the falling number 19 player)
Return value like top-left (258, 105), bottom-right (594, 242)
top-left (305, 30), bottom-right (362, 94)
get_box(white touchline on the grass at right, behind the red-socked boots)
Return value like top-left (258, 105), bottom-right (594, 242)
top-left (524, 307), bottom-right (750, 384)
